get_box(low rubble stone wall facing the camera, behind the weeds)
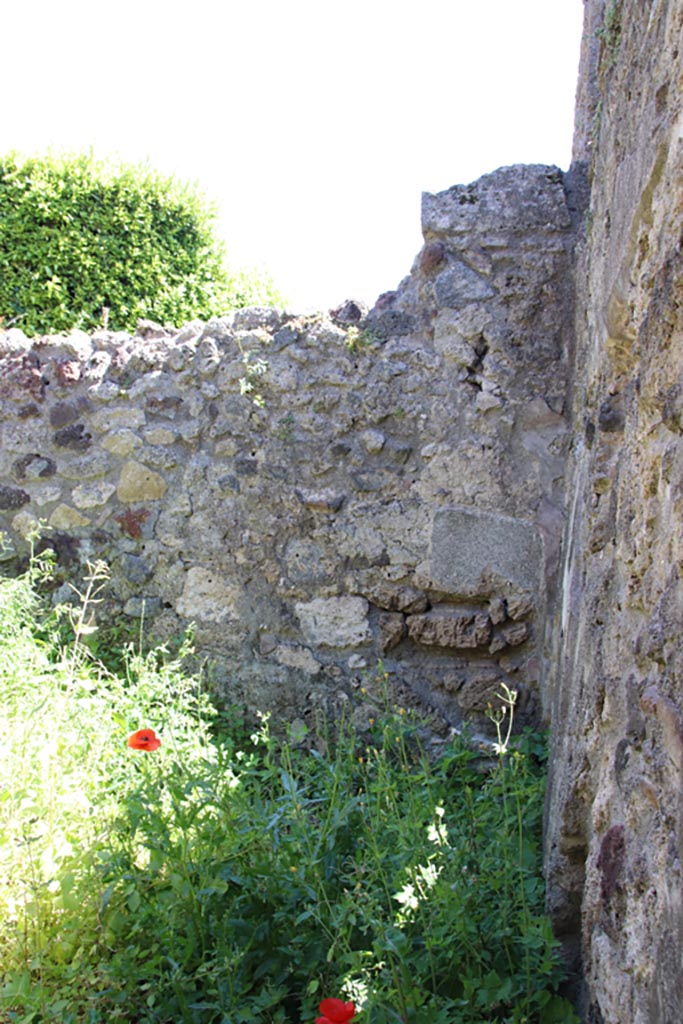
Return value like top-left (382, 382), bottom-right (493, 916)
top-left (0, 161), bottom-right (572, 727)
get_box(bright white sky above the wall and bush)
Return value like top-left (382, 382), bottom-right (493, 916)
top-left (0, 0), bottom-right (584, 310)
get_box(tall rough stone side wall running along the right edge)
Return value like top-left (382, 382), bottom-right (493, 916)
top-left (547, 0), bottom-right (683, 1024)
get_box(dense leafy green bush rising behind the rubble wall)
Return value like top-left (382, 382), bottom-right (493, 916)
top-left (0, 149), bottom-right (281, 335)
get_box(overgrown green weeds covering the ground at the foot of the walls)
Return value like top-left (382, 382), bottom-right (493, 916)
top-left (0, 566), bottom-right (575, 1024)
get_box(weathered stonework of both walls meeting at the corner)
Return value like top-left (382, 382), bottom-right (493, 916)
top-left (9, 22), bottom-right (683, 1007)
